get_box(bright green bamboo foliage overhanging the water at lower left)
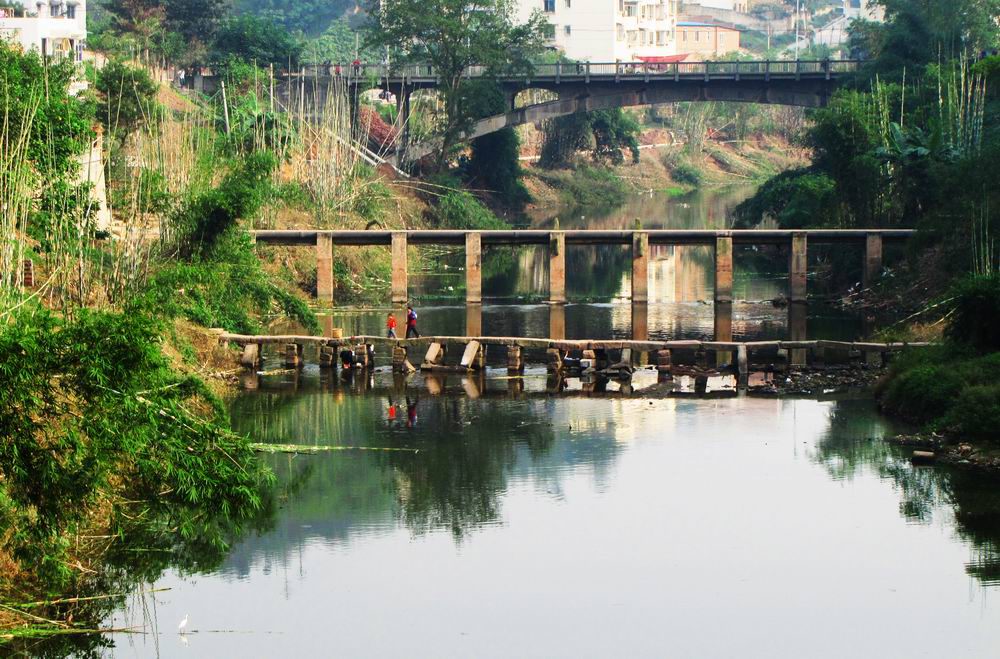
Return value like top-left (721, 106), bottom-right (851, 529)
top-left (0, 306), bottom-right (265, 587)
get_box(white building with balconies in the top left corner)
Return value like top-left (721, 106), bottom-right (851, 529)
top-left (0, 0), bottom-right (87, 61)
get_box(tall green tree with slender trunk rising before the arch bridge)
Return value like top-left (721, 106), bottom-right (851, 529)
top-left (365, 0), bottom-right (544, 168)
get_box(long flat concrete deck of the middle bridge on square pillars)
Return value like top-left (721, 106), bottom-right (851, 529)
top-left (250, 229), bottom-right (913, 245)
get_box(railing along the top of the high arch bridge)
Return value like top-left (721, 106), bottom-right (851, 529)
top-left (302, 59), bottom-right (860, 81)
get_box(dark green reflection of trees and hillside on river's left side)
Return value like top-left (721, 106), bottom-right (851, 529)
top-left (228, 376), bottom-right (619, 556)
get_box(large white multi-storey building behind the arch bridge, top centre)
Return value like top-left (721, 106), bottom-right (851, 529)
top-left (518, 0), bottom-right (677, 62)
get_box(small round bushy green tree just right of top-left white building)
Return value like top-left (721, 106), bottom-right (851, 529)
top-left (96, 60), bottom-right (157, 139)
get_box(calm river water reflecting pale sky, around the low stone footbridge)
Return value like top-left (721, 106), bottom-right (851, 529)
top-left (106, 188), bottom-right (1000, 657)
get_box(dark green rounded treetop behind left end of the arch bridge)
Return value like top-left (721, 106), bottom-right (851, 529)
top-left (211, 15), bottom-right (303, 70)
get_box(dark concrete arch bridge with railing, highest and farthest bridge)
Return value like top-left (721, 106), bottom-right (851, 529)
top-left (193, 60), bottom-right (859, 165)
